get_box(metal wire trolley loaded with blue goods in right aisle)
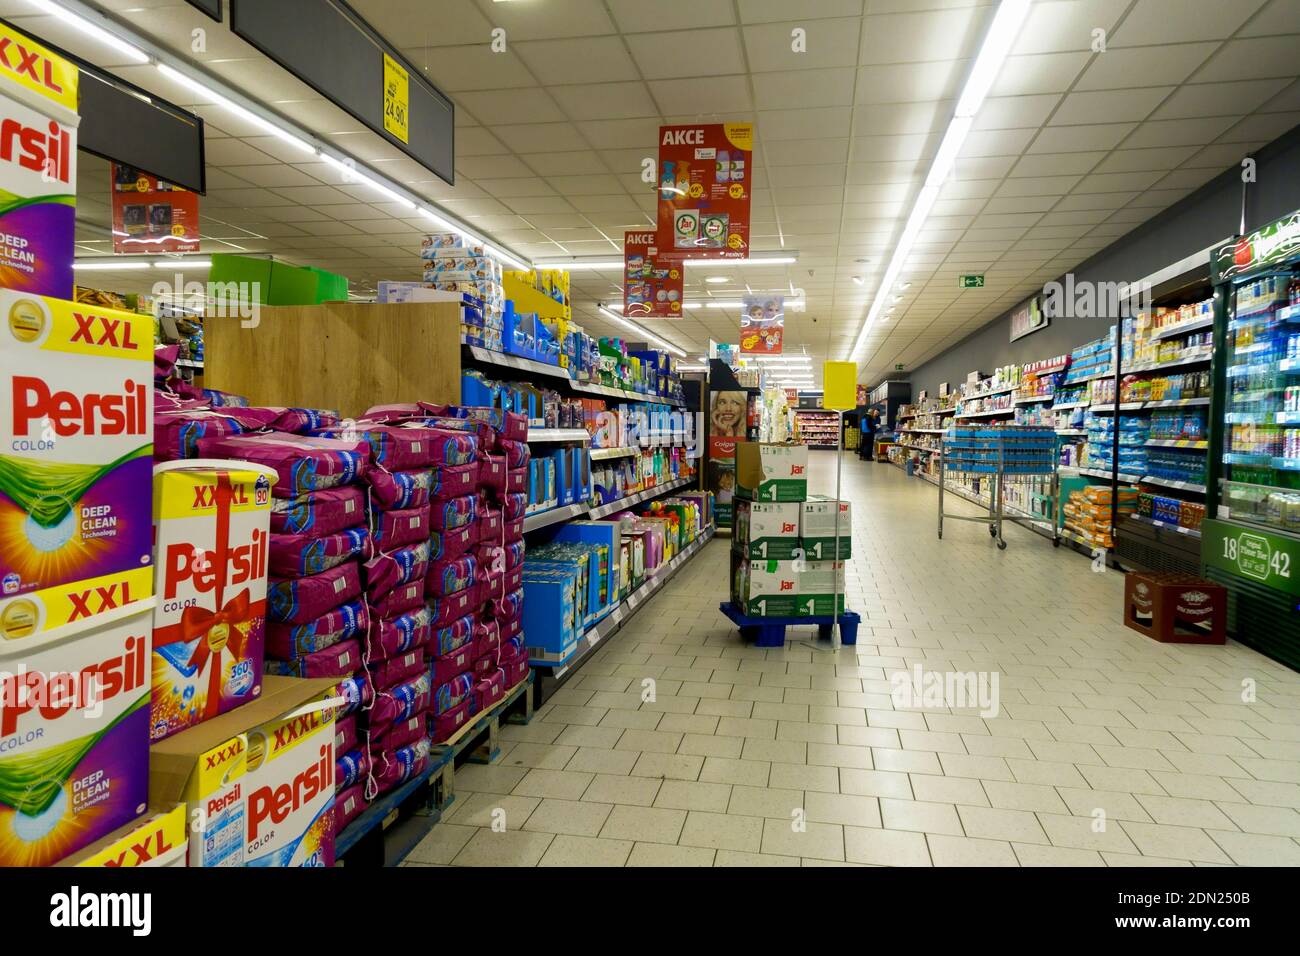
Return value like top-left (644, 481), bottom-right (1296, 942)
top-left (939, 425), bottom-right (1061, 549)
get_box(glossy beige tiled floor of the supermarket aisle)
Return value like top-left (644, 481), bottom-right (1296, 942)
top-left (408, 453), bottom-right (1300, 866)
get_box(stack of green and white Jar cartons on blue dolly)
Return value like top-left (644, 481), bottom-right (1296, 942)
top-left (731, 442), bottom-right (853, 618)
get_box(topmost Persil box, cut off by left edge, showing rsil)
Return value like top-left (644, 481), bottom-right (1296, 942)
top-left (0, 23), bottom-right (78, 299)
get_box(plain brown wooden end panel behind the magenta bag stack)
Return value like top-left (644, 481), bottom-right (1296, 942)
top-left (204, 302), bottom-right (460, 418)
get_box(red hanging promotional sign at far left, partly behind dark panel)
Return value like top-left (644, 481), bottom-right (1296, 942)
top-left (113, 163), bottom-right (199, 255)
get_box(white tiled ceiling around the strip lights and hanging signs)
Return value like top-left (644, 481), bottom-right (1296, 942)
top-left (10, 0), bottom-right (1300, 390)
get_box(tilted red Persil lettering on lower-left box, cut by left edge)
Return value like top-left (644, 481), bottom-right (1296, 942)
top-left (0, 635), bottom-right (147, 737)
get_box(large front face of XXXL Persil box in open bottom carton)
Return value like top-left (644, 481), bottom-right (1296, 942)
top-left (244, 695), bottom-right (335, 866)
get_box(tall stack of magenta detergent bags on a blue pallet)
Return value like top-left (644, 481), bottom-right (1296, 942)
top-left (159, 395), bottom-right (528, 861)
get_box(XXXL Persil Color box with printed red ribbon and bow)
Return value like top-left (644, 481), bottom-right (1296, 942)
top-left (150, 460), bottom-right (276, 740)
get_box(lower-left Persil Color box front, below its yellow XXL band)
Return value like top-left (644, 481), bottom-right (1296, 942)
top-left (0, 598), bottom-right (153, 866)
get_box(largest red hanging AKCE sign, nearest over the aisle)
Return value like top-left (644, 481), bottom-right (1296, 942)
top-left (658, 122), bottom-right (754, 259)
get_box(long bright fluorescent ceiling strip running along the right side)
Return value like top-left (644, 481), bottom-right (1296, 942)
top-left (849, 0), bottom-right (1032, 360)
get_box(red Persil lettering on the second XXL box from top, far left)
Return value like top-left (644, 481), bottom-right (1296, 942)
top-left (12, 375), bottom-right (150, 438)
